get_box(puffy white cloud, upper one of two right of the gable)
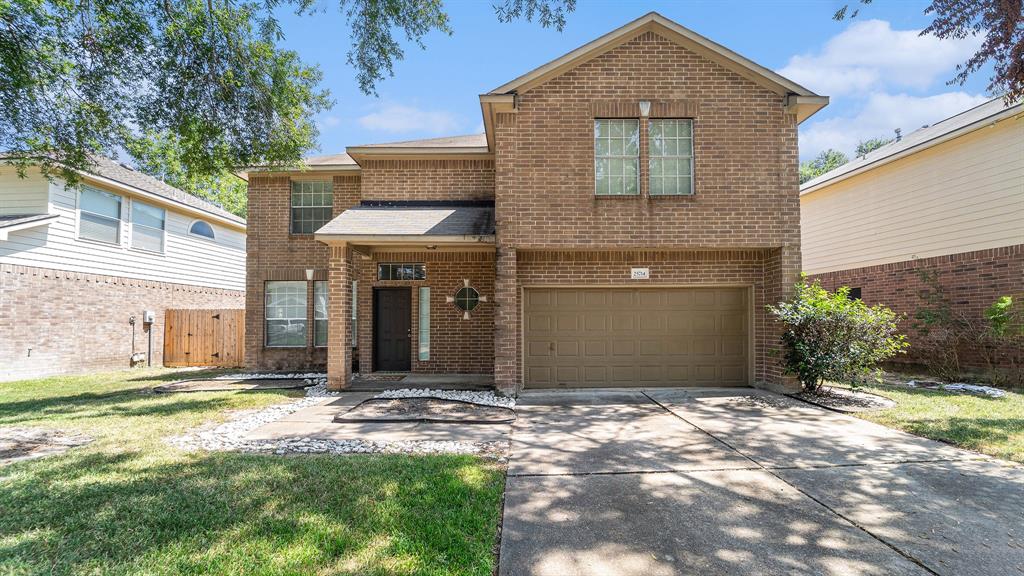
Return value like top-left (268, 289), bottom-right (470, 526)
top-left (777, 19), bottom-right (982, 96)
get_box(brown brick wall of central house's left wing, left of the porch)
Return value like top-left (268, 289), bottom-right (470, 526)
top-left (246, 173), bottom-right (359, 370)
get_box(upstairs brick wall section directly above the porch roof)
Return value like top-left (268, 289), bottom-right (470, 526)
top-left (361, 159), bottom-right (495, 200)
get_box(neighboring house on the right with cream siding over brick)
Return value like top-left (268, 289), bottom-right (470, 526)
top-left (800, 98), bottom-right (1024, 366)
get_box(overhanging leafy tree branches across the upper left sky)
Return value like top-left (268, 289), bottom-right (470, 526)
top-left (0, 0), bottom-right (575, 182)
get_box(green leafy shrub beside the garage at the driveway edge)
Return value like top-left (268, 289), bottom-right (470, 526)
top-left (768, 281), bottom-right (908, 392)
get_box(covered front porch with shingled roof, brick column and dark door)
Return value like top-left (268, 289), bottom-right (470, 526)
top-left (315, 201), bottom-right (495, 389)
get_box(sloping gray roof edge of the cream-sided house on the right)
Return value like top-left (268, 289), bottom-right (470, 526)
top-left (800, 96), bottom-right (1024, 191)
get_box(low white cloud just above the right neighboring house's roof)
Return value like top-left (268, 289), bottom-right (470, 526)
top-left (800, 92), bottom-right (989, 160)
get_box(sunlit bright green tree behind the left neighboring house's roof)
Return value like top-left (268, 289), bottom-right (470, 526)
top-left (127, 133), bottom-right (249, 218)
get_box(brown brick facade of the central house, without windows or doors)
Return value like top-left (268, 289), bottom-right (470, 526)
top-left (247, 24), bottom-right (800, 392)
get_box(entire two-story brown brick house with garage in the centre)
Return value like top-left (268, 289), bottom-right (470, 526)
top-left (246, 13), bottom-right (827, 393)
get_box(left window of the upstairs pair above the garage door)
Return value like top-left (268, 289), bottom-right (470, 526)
top-left (594, 119), bottom-right (640, 196)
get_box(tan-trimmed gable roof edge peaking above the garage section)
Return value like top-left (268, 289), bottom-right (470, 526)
top-left (488, 12), bottom-right (827, 106)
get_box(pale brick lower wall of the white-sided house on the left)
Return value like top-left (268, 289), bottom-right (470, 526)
top-left (0, 264), bottom-right (245, 380)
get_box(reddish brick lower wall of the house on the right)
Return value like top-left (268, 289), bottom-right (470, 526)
top-left (811, 245), bottom-right (1024, 368)
